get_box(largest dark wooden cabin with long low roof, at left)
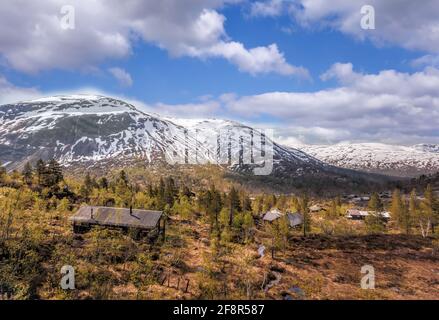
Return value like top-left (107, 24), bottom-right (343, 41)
top-left (69, 206), bottom-right (165, 238)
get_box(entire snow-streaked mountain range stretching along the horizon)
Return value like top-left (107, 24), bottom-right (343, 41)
top-left (0, 95), bottom-right (439, 181)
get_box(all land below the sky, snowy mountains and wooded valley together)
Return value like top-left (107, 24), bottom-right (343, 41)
top-left (0, 96), bottom-right (439, 300)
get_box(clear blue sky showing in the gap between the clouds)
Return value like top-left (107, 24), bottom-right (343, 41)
top-left (3, 6), bottom-right (419, 103)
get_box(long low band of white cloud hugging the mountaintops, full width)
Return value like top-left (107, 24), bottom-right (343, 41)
top-left (0, 63), bottom-right (439, 145)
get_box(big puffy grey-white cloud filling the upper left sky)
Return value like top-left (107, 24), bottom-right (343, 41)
top-left (0, 0), bottom-right (306, 75)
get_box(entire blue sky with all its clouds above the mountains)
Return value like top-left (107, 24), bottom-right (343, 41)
top-left (0, 0), bottom-right (439, 146)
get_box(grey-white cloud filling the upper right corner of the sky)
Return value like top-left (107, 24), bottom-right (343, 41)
top-left (291, 0), bottom-right (439, 53)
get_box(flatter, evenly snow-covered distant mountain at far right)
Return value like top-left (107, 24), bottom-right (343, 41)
top-left (297, 143), bottom-right (439, 177)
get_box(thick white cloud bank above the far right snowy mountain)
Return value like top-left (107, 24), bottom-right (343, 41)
top-left (227, 63), bottom-right (439, 144)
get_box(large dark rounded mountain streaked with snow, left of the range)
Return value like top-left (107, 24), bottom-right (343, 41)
top-left (0, 95), bottom-right (332, 176)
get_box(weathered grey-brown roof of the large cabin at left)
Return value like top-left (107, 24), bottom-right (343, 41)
top-left (69, 206), bottom-right (163, 229)
